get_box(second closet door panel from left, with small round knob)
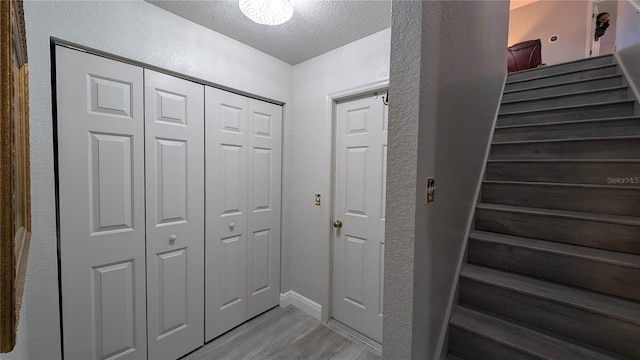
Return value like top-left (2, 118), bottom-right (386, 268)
top-left (145, 70), bottom-right (204, 359)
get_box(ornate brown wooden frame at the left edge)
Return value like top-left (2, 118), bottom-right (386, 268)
top-left (0, 0), bottom-right (31, 353)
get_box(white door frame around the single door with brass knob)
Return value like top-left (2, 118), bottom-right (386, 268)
top-left (321, 77), bottom-right (389, 336)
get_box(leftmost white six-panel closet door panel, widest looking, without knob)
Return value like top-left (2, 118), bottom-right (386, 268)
top-left (56, 46), bottom-right (147, 359)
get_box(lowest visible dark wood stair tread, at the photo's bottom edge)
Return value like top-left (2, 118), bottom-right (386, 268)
top-left (450, 306), bottom-right (613, 360)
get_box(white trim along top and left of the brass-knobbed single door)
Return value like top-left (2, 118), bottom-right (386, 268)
top-left (321, 77), bottom-right (389, 323)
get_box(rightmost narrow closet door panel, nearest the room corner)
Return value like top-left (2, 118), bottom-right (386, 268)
top-left (247, 99), bottom-right (282, 318)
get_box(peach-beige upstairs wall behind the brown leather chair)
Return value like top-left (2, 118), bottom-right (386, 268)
top-left (508, 0), bottom-right (591, 65)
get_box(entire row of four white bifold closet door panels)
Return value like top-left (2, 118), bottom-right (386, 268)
top-left (55, 46), bottom-right (282, 359)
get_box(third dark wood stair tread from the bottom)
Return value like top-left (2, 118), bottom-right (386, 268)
top-left (469, 230), bottom-right (640, 269)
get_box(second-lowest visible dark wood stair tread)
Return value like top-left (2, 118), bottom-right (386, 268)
top-left (460, 264), bottom-right (640, 325)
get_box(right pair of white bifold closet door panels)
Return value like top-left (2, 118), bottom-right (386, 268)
top-left (205, 87), bottom-right (282, 341)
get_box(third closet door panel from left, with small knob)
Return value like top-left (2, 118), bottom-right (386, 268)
top-left (205, 86), bottom-right (249, 341)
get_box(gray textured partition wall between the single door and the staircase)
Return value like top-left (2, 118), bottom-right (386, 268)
top-left (383, 1), bottom-right (509, 359)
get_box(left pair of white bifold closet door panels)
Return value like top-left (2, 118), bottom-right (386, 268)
top-left (56, 46), bottom-right (204, 359)
